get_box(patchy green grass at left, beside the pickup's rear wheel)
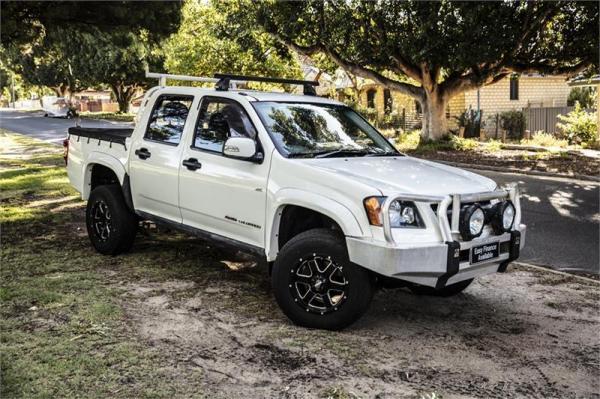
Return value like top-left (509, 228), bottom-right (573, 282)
top-left (0, 131), bottom-right (201, 398)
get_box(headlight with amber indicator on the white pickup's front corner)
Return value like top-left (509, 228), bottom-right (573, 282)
top-left (364, 197), bottom-right (425, 227)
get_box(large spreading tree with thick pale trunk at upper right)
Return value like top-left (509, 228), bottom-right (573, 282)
top-left (222, 0), bottom-right (599, 138)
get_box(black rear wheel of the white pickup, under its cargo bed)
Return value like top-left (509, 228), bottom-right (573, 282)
top-left (85, 184), bottom-right (138, 255)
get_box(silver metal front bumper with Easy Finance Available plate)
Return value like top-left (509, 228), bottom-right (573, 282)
top-left (346, 224), bottom-right (526, 288)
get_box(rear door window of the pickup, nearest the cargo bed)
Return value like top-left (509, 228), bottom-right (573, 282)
top-left (144, 95), bottom-right (194, 145)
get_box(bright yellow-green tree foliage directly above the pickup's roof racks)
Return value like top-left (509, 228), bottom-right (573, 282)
top-left (164, 0), bottom-right (302, 85)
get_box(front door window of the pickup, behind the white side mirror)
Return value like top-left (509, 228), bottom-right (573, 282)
top-left (193, 97), bottom-right (256, 152)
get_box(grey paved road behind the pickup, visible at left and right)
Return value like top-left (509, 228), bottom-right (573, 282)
top-left (0, 111), bottom-right (600, 274)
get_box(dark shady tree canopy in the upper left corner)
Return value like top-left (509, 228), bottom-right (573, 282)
top-left (1, 1), bottom-right (182, 112)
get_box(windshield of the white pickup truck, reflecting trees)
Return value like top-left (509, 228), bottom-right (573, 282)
top-left (252, 102), bottom-right (399, 157)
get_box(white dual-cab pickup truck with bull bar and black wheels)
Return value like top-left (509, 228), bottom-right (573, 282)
top-left (65, 75), bottom-right (525, 329)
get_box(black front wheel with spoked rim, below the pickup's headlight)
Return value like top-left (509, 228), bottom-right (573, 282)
top-left (271, 229), bottom-right (373, 330)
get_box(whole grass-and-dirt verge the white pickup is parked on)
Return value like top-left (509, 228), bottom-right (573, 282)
top-left (0, 135), bottom-right (600, 399)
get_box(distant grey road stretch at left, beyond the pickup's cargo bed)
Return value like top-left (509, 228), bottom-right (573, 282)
top-left (0, 109), bottom-right (132, 144)
